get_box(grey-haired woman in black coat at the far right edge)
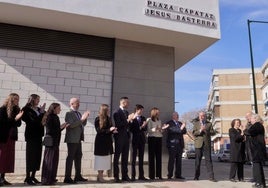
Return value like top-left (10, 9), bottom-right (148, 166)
top-left (245, 114), bottom-right (266, 187)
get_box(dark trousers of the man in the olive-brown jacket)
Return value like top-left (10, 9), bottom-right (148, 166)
top-left (195, 146), bottom-right (214, 178)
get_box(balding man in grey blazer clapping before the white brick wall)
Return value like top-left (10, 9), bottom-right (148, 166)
top-left (64, 98), bottom-right (90, 184)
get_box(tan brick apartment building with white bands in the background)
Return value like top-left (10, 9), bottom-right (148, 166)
top-left (207, 66), bottom-right (268, 150)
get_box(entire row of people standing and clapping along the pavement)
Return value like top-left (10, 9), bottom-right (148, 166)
top-left (0, 93), bottom-right (266, 187)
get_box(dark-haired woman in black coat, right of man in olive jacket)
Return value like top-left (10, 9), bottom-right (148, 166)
top-left (229, 119), bottom-right (245, 182)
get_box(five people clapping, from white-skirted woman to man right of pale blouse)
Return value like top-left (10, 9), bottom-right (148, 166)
top-left (94, 97), bottom-right (186, 183)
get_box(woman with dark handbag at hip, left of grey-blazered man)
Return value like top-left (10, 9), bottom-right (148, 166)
top-left (41, 103), bottom-right (68, 185)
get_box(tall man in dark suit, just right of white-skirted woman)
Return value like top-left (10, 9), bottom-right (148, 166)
top-left (113, 97), bottom-right (133, 182)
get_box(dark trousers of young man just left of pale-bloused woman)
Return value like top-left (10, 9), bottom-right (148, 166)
top-left (131, 143), bottom-right (145, 178)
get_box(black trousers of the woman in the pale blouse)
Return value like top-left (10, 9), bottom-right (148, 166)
top-left (148, 137), bottom-right (162, 179)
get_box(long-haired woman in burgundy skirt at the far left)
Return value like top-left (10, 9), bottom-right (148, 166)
top-left (0, 93), bottom-right (23, 185)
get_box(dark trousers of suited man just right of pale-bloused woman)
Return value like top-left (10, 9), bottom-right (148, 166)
top-left (167, 147), bottom-right (182, 178)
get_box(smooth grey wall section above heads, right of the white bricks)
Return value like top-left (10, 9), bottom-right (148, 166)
top-left (112, 40), bottom-right (175, 121)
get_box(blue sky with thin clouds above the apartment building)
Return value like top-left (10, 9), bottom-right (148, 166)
top-left (175, 0), bottom-right (268, 115)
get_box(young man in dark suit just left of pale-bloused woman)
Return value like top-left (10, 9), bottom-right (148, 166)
top-left (130, 104), bottom-right (147, 181)
